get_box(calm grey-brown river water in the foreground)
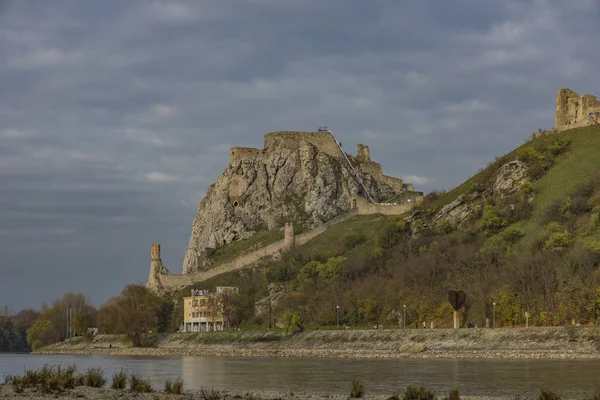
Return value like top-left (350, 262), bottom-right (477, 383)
top-left (0, 353), bottom-right (600, 397)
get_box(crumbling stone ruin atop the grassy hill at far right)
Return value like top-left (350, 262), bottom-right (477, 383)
top-left (554, 88), bottom-right (600, 131)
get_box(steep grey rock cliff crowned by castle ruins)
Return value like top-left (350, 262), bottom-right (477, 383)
top-left (183, 132), bottom-right (412, 274)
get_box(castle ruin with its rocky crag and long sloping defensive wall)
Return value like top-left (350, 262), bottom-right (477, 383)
top-left (148, 131), bottom-right (423, 291)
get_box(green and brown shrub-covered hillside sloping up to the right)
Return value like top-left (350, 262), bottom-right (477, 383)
top-left (169, 126), bottom-right (600, 328)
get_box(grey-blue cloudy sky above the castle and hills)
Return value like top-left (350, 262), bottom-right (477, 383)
top-left (0, 0), bottom-right (600, 311)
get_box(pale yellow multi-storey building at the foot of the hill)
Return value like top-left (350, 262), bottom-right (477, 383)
top-left (181, 286), bottom-right (238, 332)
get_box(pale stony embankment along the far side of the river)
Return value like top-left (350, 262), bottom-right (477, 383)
top-left (34, 327), bottom-right (600, 359)
